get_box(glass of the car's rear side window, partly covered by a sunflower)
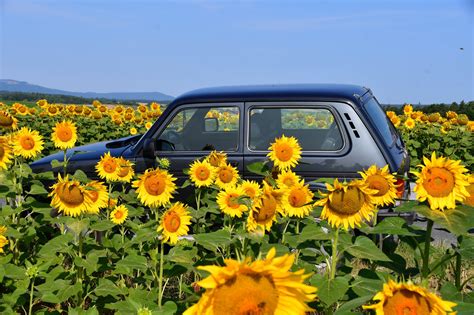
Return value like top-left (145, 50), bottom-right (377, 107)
top-left (249, 107), bottom-right (343, 151)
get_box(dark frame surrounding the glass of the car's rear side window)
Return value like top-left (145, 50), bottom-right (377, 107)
top-left (244, 101), bottom-right (350, 156)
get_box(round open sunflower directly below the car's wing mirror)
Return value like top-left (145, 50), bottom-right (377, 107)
top-left (133, 168), bottom-right (176, 207)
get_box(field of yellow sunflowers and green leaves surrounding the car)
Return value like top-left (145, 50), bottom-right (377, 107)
top-left (0, 100), bottom-right (474, 315)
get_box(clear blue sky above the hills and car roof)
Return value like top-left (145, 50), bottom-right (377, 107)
top-left (0, 0), bottom-right (474, 104)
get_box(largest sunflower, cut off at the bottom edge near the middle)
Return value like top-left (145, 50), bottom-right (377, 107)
top-left (184, 248), bottom-right (317, 315)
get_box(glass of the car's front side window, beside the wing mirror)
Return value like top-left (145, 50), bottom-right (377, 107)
top-left (158, 106), bottom-right (240, 151)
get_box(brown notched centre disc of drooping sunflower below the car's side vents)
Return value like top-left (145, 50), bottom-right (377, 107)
top-left (329, 187), bottom-right (365, 215)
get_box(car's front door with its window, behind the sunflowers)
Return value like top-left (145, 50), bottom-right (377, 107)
top-left (142, 103), bottom-right (243, 184)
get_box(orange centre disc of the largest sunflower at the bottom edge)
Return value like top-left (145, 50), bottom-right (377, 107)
top-left (213, 274), bottom-right (278, 315)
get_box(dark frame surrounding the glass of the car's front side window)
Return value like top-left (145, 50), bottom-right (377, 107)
top-left (150, 102), bottom-right (244, 155)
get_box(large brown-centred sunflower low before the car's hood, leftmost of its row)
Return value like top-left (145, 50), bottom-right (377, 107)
top-left (49, 174), bottom-right (91, 217)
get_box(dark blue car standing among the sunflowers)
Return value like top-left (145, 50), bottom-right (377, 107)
top-left (31, 84), bottom-right (409, 209)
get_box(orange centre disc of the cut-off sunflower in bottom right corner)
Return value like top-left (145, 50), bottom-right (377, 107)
top-left (383, 289), bottom-right (431, 315)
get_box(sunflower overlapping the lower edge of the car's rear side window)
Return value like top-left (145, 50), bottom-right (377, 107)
top-left (267, 135), bottom-right (301, 171)
